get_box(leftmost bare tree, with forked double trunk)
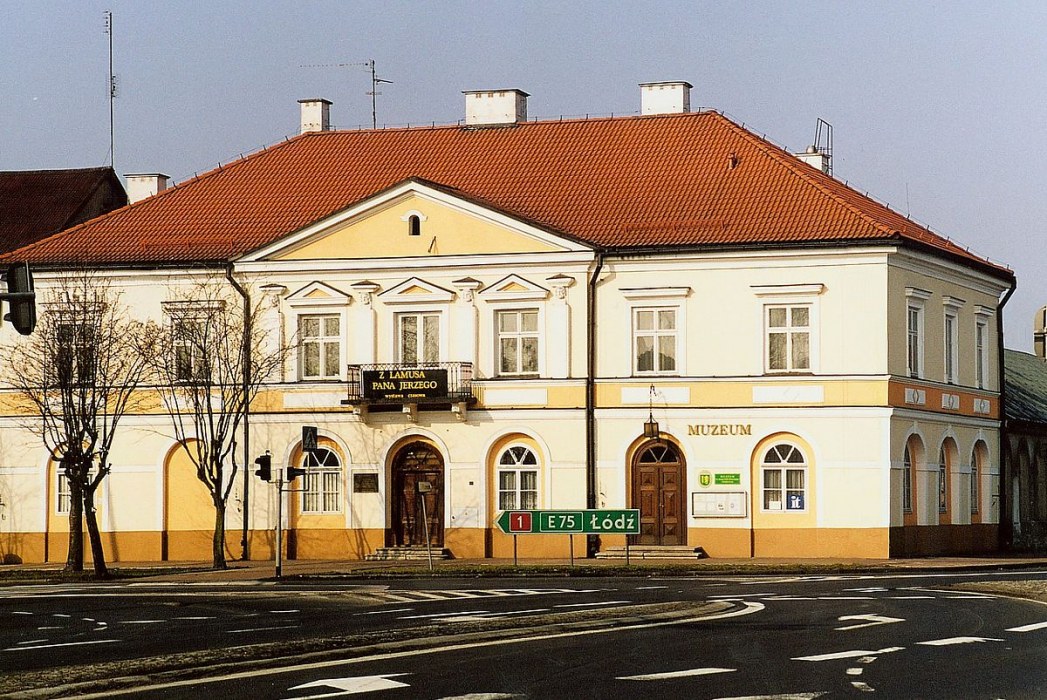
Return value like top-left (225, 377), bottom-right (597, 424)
top-left (5, 271), bottom-right (156, 578)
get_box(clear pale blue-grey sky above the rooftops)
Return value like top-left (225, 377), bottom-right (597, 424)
top-left (0, 0), bottom-right (1047, 349)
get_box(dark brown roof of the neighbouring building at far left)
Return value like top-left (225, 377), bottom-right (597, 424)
top-left (0, 167), bottom-right (128, 251)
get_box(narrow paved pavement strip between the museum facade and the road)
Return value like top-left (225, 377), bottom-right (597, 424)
top-left (8, 555), bottom-right (1047, 583)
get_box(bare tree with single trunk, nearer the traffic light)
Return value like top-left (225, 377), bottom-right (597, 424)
top-left (156, 277), bottom-right (290, 569)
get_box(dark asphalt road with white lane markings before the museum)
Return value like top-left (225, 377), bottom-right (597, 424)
top-left (6, 572), bottom-right (1047, 699)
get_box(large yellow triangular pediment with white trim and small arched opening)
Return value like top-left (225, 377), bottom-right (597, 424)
top-left (244, 180), bottom-right (588, 261)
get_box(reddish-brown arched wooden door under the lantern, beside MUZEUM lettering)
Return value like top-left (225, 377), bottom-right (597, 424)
top-left (631, 443), bottom-right (687, 545)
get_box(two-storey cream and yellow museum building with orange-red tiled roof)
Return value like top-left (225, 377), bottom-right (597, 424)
top-left (0, 82), bottom-right (1015, 561)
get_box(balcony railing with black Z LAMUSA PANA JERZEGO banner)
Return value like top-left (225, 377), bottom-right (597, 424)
top-left (346, 362), bottom-right (475, 405)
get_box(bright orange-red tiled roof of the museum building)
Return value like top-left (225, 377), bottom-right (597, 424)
top-left (4, 112), bottom-right (1012, 278)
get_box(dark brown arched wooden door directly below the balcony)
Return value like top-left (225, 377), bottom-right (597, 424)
top-left (389, 442), bottom-right (444, 546)
